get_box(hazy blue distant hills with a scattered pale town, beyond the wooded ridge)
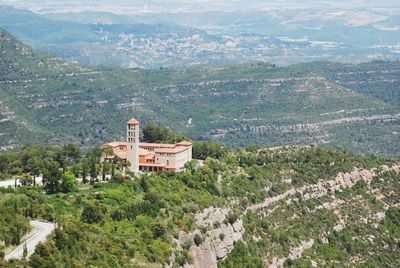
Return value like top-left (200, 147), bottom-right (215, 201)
top-left (0, 6), bottom-right (399, 68)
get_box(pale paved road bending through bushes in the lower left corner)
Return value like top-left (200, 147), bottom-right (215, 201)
top-left (4, 221), bottom-right (56, 260)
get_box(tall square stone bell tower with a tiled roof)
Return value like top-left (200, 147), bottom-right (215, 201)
top-left (126, 118), bottom-right (140, 173)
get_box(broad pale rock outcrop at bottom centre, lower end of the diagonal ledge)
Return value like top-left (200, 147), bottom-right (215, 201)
top-left (180, 207), bottom-right (244, 268)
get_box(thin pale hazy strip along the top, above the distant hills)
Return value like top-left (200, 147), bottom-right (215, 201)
top-left (0, 0), bottom-right (400, 14)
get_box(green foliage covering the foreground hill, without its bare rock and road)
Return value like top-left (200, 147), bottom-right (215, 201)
top-left (0, 142), bottom-right (400, 267)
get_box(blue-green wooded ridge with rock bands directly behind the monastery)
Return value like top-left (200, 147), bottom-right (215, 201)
top-left (0, 27), bottom-right (400, 155)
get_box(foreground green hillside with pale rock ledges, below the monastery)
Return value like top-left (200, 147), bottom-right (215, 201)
top-left (0, 146), bottom-right (400, 268)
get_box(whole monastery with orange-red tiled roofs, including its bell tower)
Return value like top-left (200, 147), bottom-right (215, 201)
top-left (102, 118), bottom-right (192, 173)
